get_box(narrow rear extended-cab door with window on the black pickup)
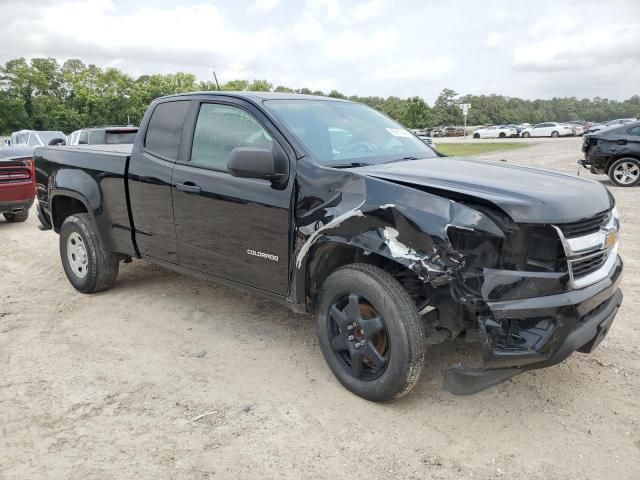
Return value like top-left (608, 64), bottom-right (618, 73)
top-left (129, 100), bottom-right (190, 264)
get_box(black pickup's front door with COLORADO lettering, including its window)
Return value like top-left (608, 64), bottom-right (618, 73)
top-left (172, 98), bottom-right (293, 295)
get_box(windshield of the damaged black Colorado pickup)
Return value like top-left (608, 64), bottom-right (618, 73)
top-left (264, 100), bottom-right (437, 166)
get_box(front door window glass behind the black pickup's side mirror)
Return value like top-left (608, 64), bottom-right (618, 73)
top-left (191, 103), bottom-right (273, 172)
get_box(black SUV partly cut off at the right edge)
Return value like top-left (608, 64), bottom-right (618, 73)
top-left (578, 122), bottom-right (640, 187)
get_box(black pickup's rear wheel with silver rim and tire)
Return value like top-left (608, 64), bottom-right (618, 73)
top-left (60, 213), bottom-right (119, 293)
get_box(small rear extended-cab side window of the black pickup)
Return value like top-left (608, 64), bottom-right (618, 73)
top-left (144, 100), bottom-right (189, 160)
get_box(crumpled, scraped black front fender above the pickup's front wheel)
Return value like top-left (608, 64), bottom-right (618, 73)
top-left (294, 158), bottom-right (503, 312)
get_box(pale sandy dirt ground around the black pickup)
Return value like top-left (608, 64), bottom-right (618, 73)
top-left (0, 139), bottom-right (640, 479)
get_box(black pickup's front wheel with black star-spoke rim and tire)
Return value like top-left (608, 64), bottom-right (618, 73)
top-left (316, 263), bottom-right (426, 402)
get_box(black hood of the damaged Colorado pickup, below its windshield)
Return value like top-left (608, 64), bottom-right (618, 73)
top-left (353, 157), bottom-right (612, 223)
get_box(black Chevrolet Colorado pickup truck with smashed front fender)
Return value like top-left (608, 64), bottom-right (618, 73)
top-left (35, 92), bottom-right (622, 401)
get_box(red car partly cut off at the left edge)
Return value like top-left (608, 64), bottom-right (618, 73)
top-left (0, 146), bottom-right (36, 222)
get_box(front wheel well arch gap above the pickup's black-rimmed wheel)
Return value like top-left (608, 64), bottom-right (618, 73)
top-left (307, 242), bottom-right (424, 310)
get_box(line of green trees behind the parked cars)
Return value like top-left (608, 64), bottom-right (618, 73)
top-left (0, 58), bottom-right (640, 135)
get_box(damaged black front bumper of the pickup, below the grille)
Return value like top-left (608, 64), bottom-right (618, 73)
top-left (444, 257), bottom-right (623, 395)
